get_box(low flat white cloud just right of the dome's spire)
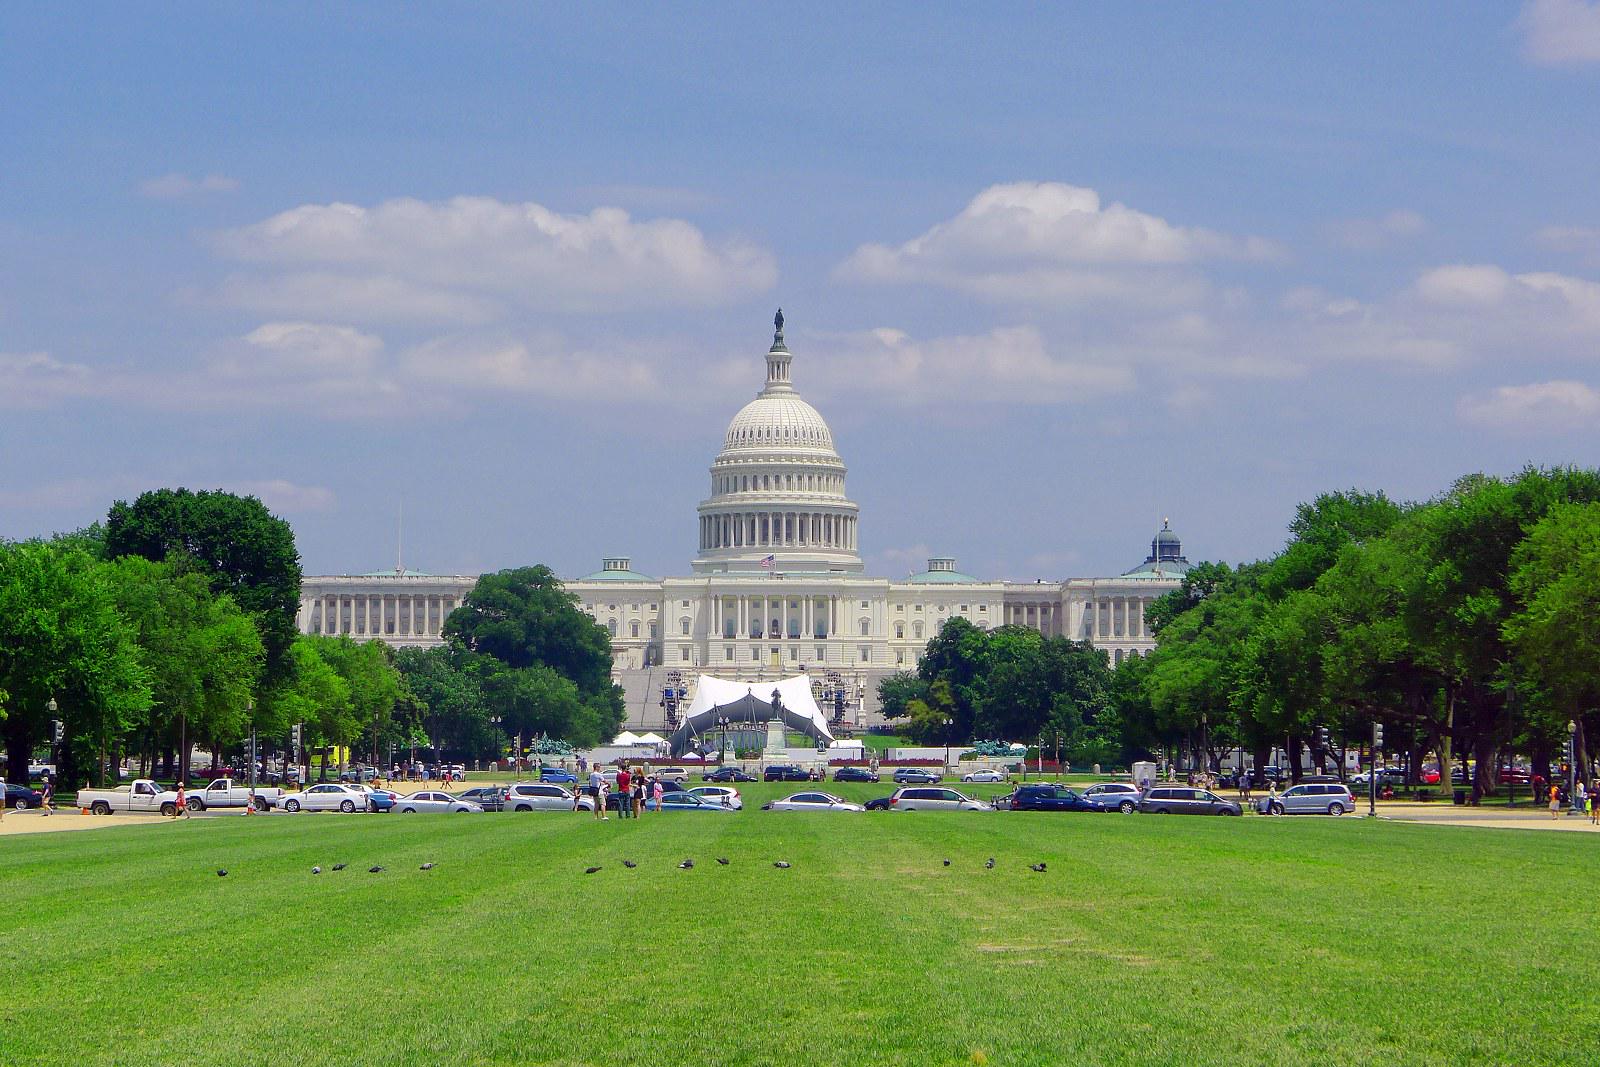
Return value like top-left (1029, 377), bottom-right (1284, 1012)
top-left (806, 326), bottom-right (1134, 405)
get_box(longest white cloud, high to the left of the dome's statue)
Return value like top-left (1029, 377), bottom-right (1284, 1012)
top-left (218, 197), bottom-right (778, 323)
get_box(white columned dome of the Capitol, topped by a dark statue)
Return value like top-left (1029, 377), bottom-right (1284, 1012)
top-left (694, 310), bottom-right (862, 573)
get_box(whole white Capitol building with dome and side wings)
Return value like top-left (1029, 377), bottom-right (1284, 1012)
top-left (298, 312), bottom-right (1189, 729)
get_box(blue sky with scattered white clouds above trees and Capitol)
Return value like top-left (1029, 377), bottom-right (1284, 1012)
top-left (0, 0), bottom-right (1600, 581)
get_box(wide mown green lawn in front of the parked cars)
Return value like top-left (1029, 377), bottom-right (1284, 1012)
top-left (0, 785), bottom-right (1600, 1067)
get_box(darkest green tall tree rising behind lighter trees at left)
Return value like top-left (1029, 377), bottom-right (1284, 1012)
top-left (106, 490), bottom-right (301, 685)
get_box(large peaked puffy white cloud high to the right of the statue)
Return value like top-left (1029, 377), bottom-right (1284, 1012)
top-left (835, 182), bottom-right (1277, 304)
